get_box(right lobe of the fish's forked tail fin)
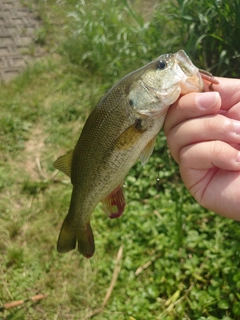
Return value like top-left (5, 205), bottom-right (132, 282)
top-left (77, 221), bottom-right (95, 258)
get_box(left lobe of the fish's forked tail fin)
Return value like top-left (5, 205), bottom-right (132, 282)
top-left (57, 217), bottom-right (77, 253)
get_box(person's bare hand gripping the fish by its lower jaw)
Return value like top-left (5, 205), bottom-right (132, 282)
top-left (164, 78), bottom-right (240, 221)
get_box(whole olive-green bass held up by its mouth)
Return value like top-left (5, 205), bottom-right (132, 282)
top-left (54, 50), bottom-right (217, 258)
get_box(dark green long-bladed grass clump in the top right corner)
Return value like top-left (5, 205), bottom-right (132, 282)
top-left (148, 0), bottom-right (240, 76)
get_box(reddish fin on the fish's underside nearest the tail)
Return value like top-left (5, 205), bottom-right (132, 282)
top-left (102, 186), bottom-right (126, 219)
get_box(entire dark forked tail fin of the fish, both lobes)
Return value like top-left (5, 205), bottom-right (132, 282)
top-left (57, 217), bottom-right (95, 258)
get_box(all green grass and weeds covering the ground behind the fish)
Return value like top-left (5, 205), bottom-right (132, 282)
top-left (0, 0), bottom-right (240, 320)
